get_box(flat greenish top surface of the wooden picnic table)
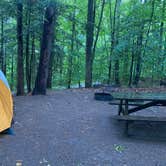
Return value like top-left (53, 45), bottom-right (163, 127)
top-left (111, 92), bottom-right (166, 101)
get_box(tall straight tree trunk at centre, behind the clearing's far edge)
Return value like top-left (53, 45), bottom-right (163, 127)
top-left (85, 0), bottom-right (95, 88)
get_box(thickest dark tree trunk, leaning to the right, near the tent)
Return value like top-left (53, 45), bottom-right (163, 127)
top-left (33, 3), bottom-right (55, 95)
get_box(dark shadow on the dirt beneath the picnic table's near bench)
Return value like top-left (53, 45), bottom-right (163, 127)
top-left (111, 118), bottom-right (166, 142)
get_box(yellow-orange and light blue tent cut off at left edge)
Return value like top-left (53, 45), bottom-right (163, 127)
top-left (0, 71), bottom-right (13, 132)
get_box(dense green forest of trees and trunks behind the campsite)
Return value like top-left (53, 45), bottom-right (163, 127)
top-left (0, 0), bottom-right (166, 95)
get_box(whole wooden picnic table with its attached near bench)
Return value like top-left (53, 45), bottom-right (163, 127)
top-left (109, 92), bottom-right (166, 135)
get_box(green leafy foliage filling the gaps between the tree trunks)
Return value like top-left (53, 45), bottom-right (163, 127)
top-left (0, 0), bottom-right (166, 91)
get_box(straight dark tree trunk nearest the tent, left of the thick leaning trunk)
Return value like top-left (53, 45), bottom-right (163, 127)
top-left (17, 0), bottom-right (24, 95)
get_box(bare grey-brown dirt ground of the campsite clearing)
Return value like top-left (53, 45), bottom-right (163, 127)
top-left (0, 89), bottom-right (166, 166)
